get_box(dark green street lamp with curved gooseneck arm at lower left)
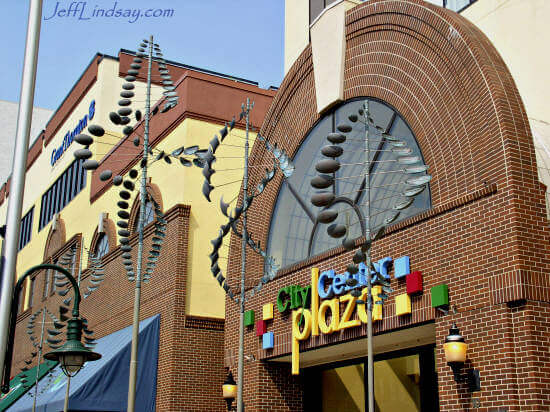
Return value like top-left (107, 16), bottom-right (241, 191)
top-left (2, 264), bottom-right (101, 393)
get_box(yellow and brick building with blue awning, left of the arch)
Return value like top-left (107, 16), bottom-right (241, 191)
top-left (0, 50), bottom-right (275, 411)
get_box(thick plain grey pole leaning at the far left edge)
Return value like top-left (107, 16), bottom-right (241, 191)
top-left (0, 0), bottom-right (42, 380)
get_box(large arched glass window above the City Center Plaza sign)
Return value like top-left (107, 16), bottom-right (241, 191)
top-left (268, 98), bottom-right (431, 267)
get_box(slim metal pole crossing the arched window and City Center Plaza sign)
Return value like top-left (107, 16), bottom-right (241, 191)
top-left (364, 101), bottom-right (374, 412)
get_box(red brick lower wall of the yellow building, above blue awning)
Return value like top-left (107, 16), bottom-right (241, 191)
top-left (12, 206), bottom-right (229, 411)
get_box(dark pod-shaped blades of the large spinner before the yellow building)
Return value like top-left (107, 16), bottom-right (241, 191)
top-left (70, 41), bottom-right (211, 286)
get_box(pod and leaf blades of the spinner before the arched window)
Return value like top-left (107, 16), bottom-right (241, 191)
top-left (311, 101), bottom-right (431, 304)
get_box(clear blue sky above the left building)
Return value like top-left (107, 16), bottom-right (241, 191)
top-left (0, 0), bottom-right (284, 110)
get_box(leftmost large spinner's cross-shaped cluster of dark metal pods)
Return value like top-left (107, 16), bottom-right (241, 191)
top-left (74, 39), bottom-right (207, 286)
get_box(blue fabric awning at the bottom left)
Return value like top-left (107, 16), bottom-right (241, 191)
top-left (8, 315), bottom-right (160, 412)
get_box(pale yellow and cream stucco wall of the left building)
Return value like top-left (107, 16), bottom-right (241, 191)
top-left (0, 55), bottom-right (253, 318)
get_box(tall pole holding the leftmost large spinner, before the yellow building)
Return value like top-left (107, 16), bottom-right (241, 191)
top-left (128, 36), bottom-right (153, 412)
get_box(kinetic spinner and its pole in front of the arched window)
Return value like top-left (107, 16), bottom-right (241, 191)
top-left (311, 100), bottom-right (431, 411)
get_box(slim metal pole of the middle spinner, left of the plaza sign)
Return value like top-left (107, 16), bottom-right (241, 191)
top-left (237, 98), bottom-right (250, 412)
